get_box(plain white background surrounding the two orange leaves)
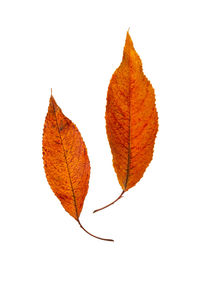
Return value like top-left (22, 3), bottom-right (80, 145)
top-left (0, 0), bottom-right (200, 300)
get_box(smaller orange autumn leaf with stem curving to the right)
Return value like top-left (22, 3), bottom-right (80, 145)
top-left (43, 91), bottom-right (113, 241)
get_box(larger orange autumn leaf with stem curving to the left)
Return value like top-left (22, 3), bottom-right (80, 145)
top-left (94, 32), bottom-right (158, 212)
